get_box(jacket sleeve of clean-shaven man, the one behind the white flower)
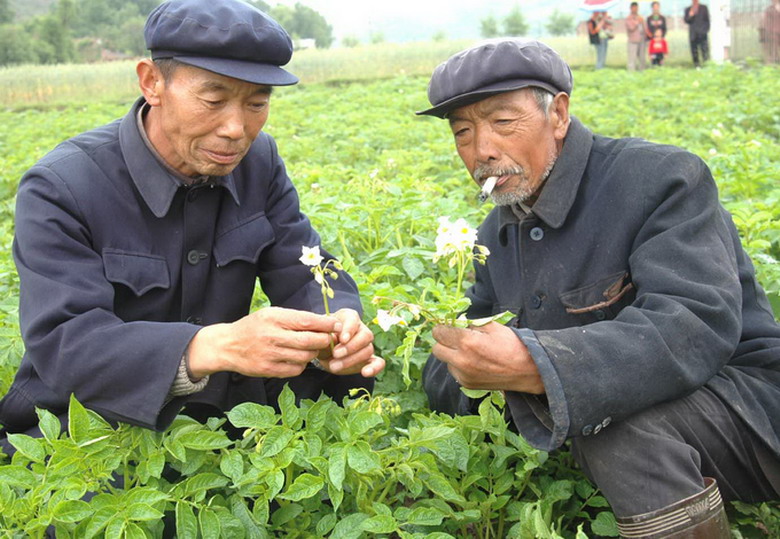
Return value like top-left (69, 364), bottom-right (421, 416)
top-left (258, 137), bottom-right (362, 313)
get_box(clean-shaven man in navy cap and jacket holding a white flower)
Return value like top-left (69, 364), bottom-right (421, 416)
top-left (0, 0), bottom-right (384, 450)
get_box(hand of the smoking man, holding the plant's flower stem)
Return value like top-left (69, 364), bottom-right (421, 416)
top-left (433, 322), bottom-right (544, 394)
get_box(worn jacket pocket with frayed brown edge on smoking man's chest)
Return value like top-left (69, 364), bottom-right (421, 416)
top-left (560, 271), bottom-right (636, 321)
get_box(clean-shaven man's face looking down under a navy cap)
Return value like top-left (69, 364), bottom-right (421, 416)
top-left (146, 65), bottom-right (271, 176)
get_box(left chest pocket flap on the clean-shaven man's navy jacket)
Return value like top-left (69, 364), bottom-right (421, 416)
top-left (102, 249), bottom-right (171, 296)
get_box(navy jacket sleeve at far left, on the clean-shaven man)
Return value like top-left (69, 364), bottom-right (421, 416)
top-left (13, 165), bottom-right (198, 428)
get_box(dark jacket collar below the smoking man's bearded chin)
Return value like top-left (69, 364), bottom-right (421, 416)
top-left (498, 116), bottom-right (593, 231)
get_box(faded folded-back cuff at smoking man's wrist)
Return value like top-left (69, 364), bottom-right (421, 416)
top-left (506, 328), bottom-right (569, 451)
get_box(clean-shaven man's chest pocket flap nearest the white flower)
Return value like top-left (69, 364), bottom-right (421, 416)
top-left (214, 213), bottom-right (276, 267)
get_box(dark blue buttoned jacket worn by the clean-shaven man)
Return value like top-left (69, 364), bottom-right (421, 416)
top-left (0, 100), bottom-right (361, 432)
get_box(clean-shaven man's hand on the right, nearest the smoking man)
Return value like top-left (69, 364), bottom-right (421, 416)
top-left (319, 309), bottom-right (385, 378)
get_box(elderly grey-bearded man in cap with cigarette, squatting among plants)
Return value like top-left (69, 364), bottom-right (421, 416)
top-left (420, 40), bottom-right (780, 537)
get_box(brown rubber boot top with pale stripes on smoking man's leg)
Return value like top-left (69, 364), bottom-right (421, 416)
top-left (617, 477), bottom-right (731, 539)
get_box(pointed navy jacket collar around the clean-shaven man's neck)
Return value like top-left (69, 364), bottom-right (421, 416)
top-left (119, 98), bottom-right (240, 218)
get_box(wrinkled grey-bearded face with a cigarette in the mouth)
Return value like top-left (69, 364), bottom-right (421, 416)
top-left (449, 89), bottom-right (568, 205)
